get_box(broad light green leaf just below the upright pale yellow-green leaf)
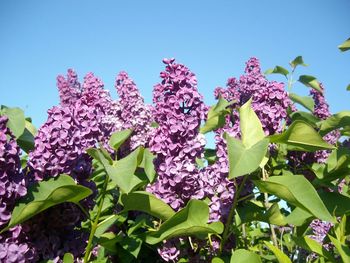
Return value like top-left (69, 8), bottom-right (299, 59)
top-left (225, 134), bottom-right (269, 179)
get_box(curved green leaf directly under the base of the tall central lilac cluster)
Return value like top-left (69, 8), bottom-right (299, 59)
top-left (121, 191), bottom-right (175, 221)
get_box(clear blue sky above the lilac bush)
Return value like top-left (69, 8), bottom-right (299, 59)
top-left (0, 0), bottom-right (350, 126)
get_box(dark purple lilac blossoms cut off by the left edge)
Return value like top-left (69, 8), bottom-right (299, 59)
top-left (0, 117), bottom-right (35, 263)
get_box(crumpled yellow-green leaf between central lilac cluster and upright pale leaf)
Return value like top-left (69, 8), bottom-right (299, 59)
top-left (200, 97), bottom-right (234, 134)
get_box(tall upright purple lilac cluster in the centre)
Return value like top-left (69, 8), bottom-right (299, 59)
top-left (148, 59), bottom-right (206, 210)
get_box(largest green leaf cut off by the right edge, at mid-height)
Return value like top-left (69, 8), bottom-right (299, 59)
top-left (319, 111), bottom-right (350, 136)
